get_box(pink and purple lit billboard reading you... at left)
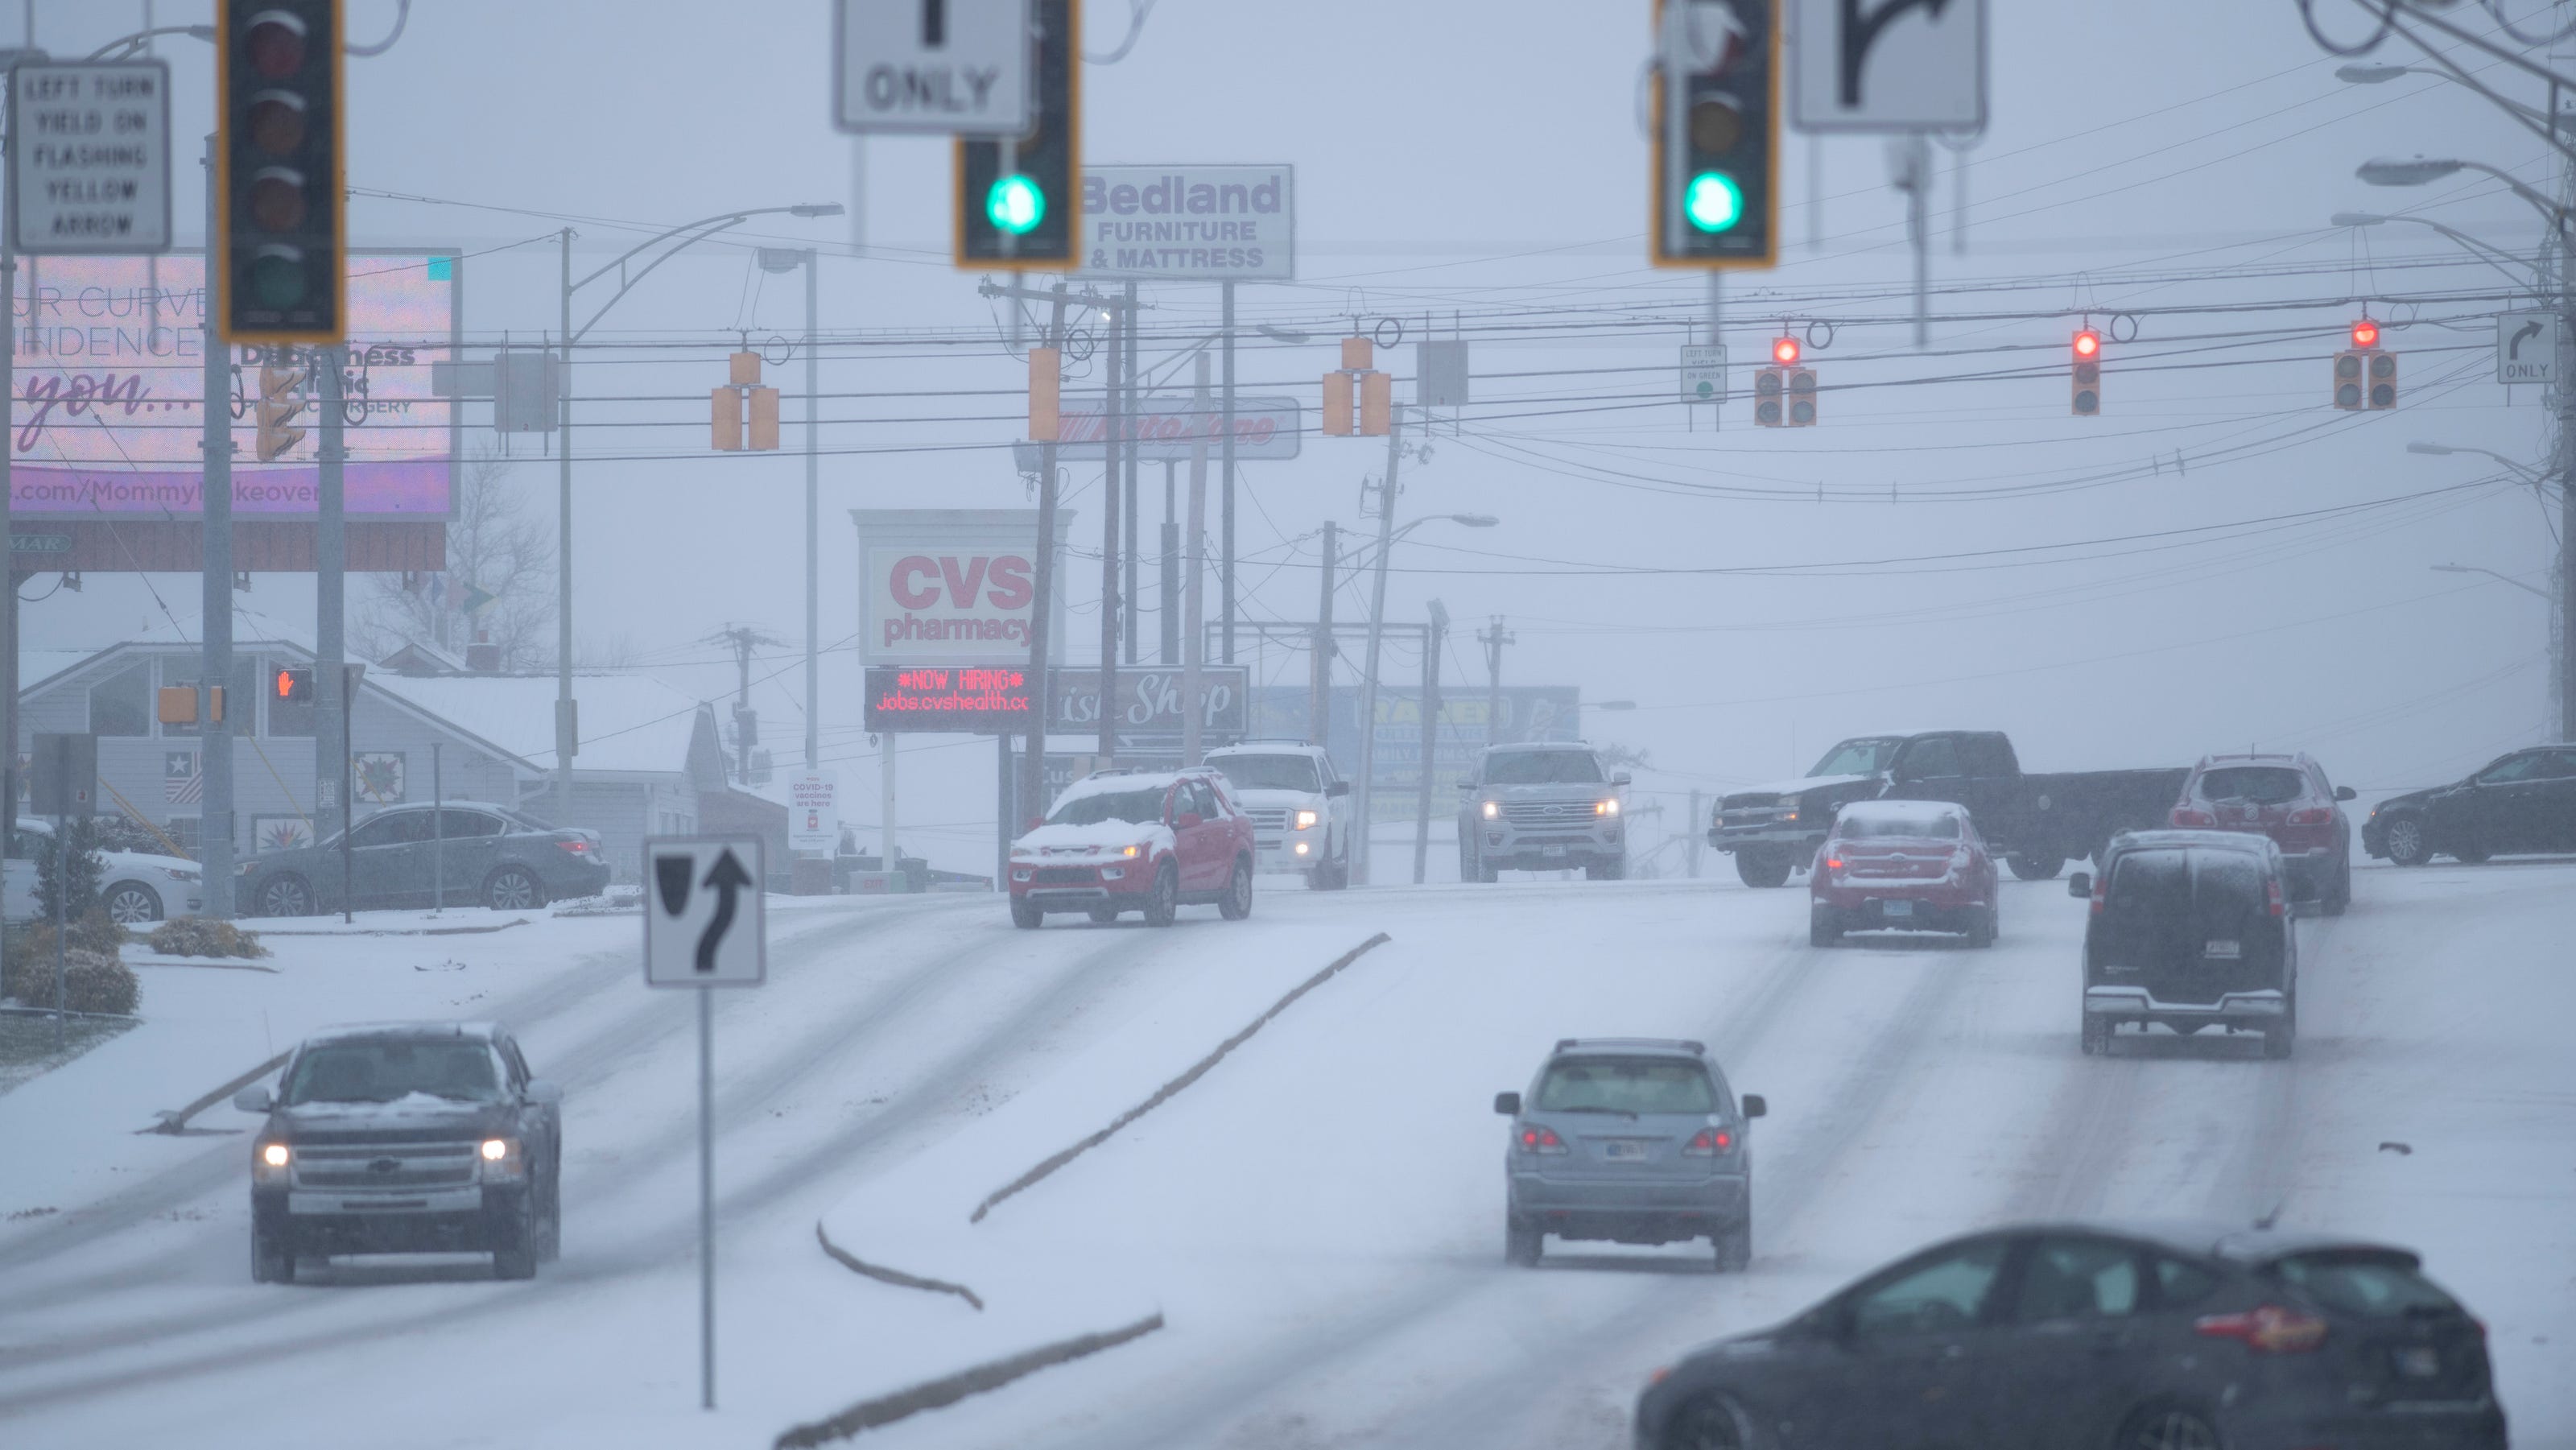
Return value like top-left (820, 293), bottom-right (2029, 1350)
top-left (8, 252), bottom-right (464, 523)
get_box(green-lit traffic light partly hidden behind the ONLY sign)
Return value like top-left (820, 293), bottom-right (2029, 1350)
top-left (956, 0), bottom-right (1082, 271)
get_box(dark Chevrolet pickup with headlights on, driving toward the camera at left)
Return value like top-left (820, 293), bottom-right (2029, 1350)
top-left (232, 1022), bottom-right (564, 1283)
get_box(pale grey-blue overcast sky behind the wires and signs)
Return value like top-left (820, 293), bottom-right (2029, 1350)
top-left (26, 0), bottom-right (2558, 865)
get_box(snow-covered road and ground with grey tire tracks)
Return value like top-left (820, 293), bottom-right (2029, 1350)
top-left (0, 860), bottom-right (2576, 1450)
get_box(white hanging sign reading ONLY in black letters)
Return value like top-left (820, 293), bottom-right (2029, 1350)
top-left (832, 0), bottom-right (1038, 137)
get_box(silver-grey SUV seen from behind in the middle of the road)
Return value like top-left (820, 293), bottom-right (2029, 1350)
top-left (1494, 1038), bottom-right (1765, 1270)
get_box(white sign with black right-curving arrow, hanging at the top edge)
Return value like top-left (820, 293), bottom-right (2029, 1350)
top-left (1790, 0), bottom-right (1986, 131)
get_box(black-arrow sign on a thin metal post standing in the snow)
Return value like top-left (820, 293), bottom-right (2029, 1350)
top-left (644, 837), bottom-right (770, 1409)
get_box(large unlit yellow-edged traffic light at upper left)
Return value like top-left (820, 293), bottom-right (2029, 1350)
top-left (214, 0), bottom-right (348, 342)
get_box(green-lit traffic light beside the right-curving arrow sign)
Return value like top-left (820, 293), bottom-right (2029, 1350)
top-left (1646, 0), bottom-right (1780, 268)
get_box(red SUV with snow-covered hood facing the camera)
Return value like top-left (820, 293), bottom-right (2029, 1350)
top-left (1009, 767), bottom-right (1254, 927)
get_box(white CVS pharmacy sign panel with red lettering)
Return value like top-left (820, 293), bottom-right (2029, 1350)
top-left (850, 507), bottom-right (1074, 667)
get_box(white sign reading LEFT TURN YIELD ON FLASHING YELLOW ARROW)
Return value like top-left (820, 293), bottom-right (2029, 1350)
top-left (8, 60), bottom-right (170, 258)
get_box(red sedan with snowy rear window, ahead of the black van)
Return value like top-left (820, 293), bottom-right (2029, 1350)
top-left (1806, 801), bottom-right (2001, 948)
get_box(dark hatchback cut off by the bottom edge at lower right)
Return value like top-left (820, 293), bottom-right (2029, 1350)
top-left (1636, 1223), bottom-right (2507, 1450)
